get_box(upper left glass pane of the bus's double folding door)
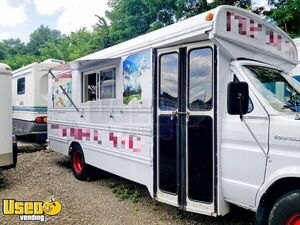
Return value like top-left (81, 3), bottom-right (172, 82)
top-left (159, 53), bottom-right (179, 110)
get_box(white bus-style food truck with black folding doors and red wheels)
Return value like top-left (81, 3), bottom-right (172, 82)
top-left (48, 6), bottom-right (300, 225)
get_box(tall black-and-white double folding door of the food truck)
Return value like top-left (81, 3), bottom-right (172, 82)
top-left (156, 43), bottom-right (215, 215)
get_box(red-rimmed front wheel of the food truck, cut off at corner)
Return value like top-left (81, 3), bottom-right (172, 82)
top-left (269, 190), bottom-right (300, 225)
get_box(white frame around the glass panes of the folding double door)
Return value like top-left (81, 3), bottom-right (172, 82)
top-left (153, 41), bottom-right (218, 215)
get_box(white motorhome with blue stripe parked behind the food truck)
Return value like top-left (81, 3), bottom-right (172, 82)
top-left (12, 59), bottom-right (64, 142)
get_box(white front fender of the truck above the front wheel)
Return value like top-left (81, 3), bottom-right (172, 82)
top-left (256, 115), bottom-right (300, 207)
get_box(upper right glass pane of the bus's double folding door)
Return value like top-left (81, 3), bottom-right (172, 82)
top-left (188, 48), bottom-right (213, 111)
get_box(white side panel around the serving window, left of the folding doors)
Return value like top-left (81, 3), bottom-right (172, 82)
top-left (48, 50), bottom-right (153, 194)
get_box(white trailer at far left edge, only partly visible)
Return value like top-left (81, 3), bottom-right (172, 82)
top-left (0, 63), bottom-right (17, 170)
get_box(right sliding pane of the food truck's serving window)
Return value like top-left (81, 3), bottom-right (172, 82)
top-left (98, 69), bottom-right (116, 99)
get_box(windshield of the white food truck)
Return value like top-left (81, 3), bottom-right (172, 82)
top-left (243, 65), bottom-right (300, 112)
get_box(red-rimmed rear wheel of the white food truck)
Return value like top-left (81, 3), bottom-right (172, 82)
top-left (71, 146), bottom-right (91, 181)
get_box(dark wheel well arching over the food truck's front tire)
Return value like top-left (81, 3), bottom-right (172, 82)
top-left (256, 177), bottom-right (300, 224)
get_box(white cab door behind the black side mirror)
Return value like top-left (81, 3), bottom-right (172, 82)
top-left (221, 66), bottom-right (269, 207)
